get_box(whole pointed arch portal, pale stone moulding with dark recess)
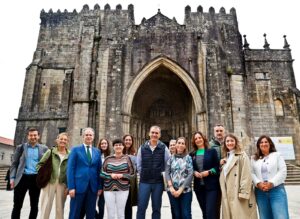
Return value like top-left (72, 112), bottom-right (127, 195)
top-left (122, 57), bottom-right (206, 145)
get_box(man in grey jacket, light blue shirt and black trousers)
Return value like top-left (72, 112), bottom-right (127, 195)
top-left (10, 128), bottom-right (48, 219)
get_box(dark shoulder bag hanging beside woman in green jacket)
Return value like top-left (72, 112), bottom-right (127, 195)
top-left (36, 149), bottom-right (52, 188)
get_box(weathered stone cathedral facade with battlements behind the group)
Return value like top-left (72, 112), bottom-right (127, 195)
top-left (15, 4), bottom-right (300, 163)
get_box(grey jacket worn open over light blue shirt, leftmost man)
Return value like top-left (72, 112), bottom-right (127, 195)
top-left (10, 143), bottom-right (48, 186)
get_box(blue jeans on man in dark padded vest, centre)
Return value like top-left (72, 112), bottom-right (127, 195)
top-left (136, 183), bottom-right (164, 219)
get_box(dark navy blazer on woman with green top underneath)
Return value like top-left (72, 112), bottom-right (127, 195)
top-left (190, 148), bottom-right (220, 191)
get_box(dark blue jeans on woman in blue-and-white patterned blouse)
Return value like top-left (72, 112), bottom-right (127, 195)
top-left (168, 191), bottom-right (193, 219)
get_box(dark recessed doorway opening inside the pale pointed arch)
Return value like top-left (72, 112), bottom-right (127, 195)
top-left (130, 66), bottom-right (192, 146)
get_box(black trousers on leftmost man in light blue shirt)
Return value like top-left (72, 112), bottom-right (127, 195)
top-left (11, 174), bottom-right (41, 219)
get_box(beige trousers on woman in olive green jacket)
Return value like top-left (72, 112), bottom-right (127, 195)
top-left (40, 182), bottom-right (67, 219)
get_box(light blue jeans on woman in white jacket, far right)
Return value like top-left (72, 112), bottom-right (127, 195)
top-left (255, 184), bottom-right (289, 219)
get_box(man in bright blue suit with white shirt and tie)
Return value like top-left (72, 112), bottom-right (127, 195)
top-left (67, 128), bottom-right (102, 219)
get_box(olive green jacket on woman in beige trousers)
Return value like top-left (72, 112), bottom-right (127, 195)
top-left (36, 147), bottom-right (70, 185)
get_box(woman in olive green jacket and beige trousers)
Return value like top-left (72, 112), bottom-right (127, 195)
top-left (37, 132), bottom-right (70, 219)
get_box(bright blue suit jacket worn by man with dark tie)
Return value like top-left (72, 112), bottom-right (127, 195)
top-left (67, 144), bottom-right (102, 193)
